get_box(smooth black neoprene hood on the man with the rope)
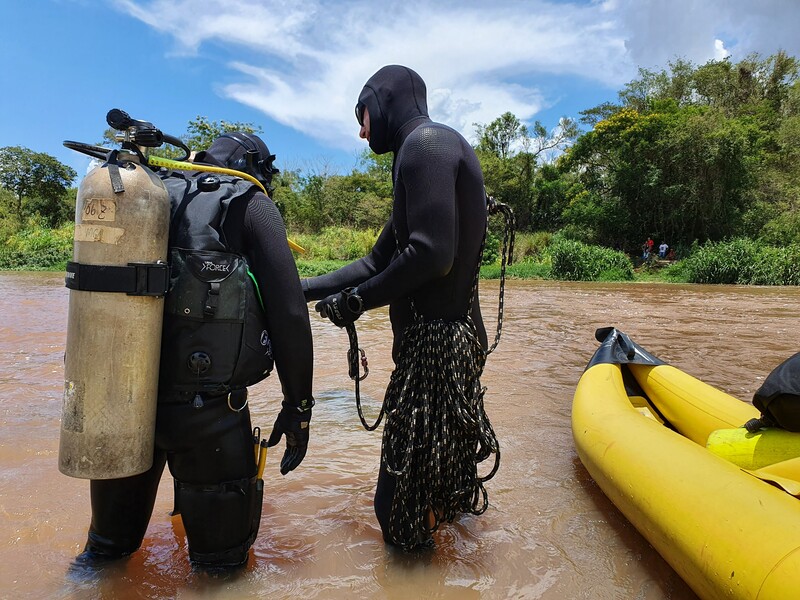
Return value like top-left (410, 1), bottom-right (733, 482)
top-left (358, 65), bottom-right (428, 154)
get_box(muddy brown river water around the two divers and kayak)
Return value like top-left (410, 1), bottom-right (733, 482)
top-left (0, 273), bottom-right (800, 600)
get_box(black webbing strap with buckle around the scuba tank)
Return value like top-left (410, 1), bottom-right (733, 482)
top-left (65, 261), bottom-right (169, 296)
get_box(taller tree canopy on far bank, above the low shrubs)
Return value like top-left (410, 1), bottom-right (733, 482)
top-left (6, 52), bottom-right (800, 252)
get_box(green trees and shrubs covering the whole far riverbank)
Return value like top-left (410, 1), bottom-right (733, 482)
top-left (0, 52), bottom-right (800, 285)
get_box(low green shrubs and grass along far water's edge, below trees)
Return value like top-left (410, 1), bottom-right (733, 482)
top-left (0, 221), bottom-right (800, 285)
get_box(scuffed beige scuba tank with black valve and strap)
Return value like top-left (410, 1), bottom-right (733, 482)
top-left (59, 109), bottom-right (188, 479)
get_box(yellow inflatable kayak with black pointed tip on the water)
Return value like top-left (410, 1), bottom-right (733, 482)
top-left (572, 328), bottom-right (800, 600)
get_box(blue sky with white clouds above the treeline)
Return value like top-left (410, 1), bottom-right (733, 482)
top-left (0, 0), bottom-right (800, 183)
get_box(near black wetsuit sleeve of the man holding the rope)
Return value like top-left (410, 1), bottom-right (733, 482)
top-left (358, 127), bottom-right (461, 308)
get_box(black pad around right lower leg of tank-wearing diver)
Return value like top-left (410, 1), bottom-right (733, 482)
top-left (176, 477), bottom-right (264, 566)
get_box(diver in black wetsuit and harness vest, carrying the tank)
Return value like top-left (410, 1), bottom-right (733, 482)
top-left (77, 132), bottom-right (314, 567)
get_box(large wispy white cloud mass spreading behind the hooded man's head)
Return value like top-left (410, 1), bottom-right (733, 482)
top-left (118, 0), bottom-right (800, 148)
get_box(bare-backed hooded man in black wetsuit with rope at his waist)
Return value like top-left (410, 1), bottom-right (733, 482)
top-left (303, 65), bottom-right (494, 549)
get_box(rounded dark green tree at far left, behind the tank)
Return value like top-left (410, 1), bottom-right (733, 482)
top-left (0, 146), bottom-right (77, 224)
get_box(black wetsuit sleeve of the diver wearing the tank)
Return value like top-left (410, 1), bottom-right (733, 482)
top-left (243, 193), bottom-right (314, 404)
